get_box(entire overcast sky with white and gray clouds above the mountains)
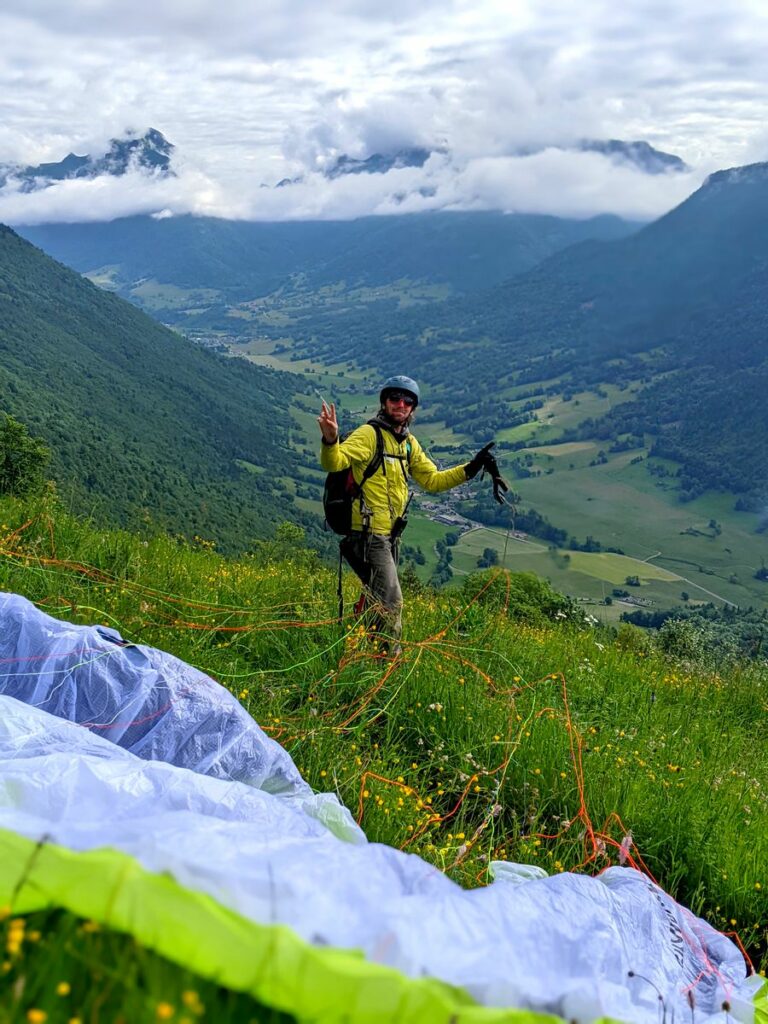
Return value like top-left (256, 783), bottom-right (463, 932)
top-left (0, 0), bottom-right (768, 223)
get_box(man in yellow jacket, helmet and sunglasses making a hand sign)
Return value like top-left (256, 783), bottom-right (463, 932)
top-left (317, 377), bottom-right (508, 654)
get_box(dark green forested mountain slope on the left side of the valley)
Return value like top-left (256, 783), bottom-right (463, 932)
top-left (0, 226), bottom-right (313, 549)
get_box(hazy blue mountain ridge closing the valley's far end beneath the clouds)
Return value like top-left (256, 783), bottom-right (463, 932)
top-left (19, 211), bottom-right (637, 301)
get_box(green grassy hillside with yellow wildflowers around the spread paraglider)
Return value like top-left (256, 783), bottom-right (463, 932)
top-left (0, 499), bottom-right (768, 1021)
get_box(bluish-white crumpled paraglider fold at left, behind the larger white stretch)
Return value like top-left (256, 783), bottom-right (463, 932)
top-left (0, 593), bottom-right (309, 793)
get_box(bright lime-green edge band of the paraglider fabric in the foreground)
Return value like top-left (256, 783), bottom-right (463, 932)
top-left (0, 829), bottom-right (573, 1024)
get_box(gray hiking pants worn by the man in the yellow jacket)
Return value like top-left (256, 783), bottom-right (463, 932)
top-left (341, 534), bottom-right (402, 646)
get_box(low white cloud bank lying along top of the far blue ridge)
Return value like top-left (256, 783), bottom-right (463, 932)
top-left (0, 148), bottom-right (703, 224)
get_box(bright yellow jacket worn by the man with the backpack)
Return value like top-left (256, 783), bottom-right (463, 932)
top-left (321, 423), bottom-right (467, 536)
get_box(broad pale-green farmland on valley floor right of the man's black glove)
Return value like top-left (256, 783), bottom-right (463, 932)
top-left (454, 444), bottom-right (768, 618)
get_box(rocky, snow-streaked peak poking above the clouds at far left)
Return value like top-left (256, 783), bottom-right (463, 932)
top-left (0, 128), bottom-right (174, 191)
